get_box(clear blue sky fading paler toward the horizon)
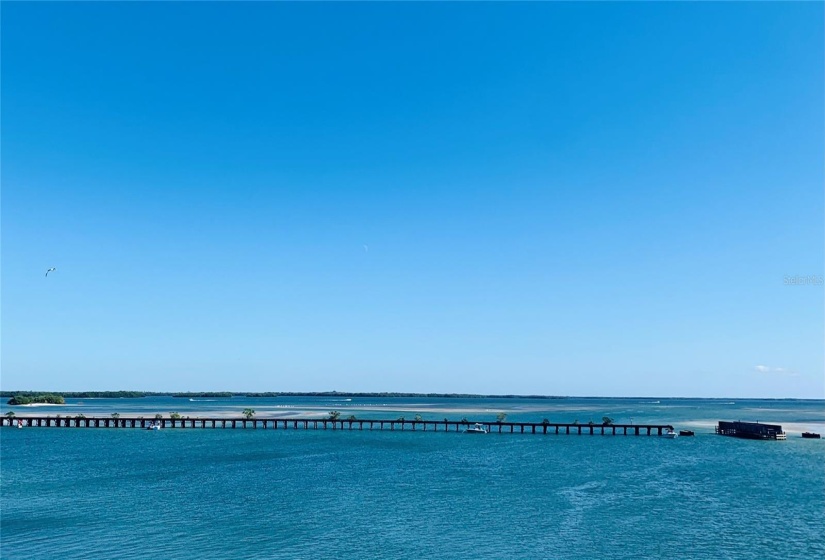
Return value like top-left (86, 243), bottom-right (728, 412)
top-left (0, 3), bottom-right (825, 398)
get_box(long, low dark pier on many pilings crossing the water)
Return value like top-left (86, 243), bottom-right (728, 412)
top-left (0, 416), bottom-right (673, 436)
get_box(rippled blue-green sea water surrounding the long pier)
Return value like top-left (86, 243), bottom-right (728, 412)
top-left (0, 398), bottom-right (825, 560)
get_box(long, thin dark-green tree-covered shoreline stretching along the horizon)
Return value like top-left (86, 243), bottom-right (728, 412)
top-left (0, 391), bottom-right (569, 399)
